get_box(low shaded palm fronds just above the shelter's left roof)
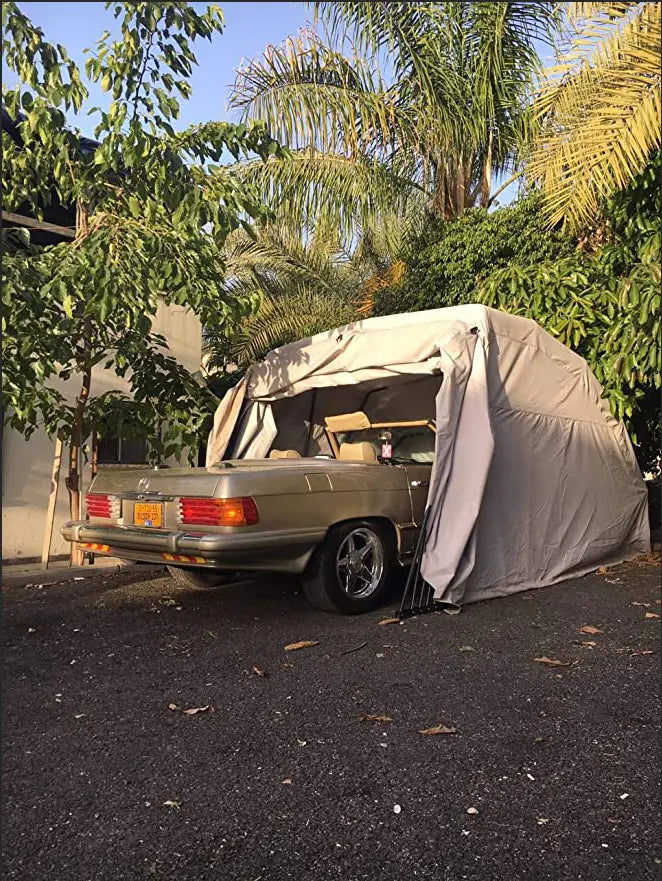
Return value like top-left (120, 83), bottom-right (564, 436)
top-left (203, 223), bottom-right (411, 378)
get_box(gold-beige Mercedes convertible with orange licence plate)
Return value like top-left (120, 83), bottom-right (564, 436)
top-left (62, 412), bottom-right (435, 614)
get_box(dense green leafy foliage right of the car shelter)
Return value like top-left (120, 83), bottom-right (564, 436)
top-left (478, 152), bottom-right (662, 470)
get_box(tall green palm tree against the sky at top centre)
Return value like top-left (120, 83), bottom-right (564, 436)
top-left (231, 2), bottom-right (556, 248)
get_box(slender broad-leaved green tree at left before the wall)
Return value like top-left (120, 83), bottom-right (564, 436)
top-left (2, 2), bottom-right (279, 518)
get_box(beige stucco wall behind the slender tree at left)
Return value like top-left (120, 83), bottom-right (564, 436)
top-left (2, 304), bottom-right (202, 560)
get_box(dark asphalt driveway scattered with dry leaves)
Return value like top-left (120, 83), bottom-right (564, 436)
top-left (3, 559), bottom-right (661, 881)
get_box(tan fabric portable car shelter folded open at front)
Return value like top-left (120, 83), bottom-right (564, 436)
top-left (207, 305), bottom-right (650, 605)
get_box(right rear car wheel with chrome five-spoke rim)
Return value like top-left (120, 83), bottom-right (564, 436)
top-left (302, 520), bottom-right (395, 615)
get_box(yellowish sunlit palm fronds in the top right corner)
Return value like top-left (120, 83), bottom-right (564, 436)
top-left (528, 2), bottom-right (662, 228)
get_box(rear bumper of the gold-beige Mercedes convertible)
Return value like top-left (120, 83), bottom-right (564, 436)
top-left (62, 520), bottom-right (326, 573)
